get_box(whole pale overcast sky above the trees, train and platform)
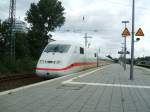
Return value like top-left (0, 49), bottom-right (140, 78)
top-left (0, 0), bottom-right (150, 57)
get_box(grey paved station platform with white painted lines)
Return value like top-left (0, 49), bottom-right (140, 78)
top-left (0, 64), bottom-right (150, 112)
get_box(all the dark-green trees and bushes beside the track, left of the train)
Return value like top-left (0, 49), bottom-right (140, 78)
top-left (0, 0), bottom-right (65, 74)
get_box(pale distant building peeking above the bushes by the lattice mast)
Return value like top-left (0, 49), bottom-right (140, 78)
top-left (5, 19), bottom-right (28, 33)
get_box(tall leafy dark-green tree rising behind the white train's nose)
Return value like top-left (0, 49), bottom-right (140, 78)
top-left (26, 0), bottom-right (65, 57)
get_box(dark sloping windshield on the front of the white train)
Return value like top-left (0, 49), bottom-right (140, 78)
top-left (44, 44), bottom-right (70, 53)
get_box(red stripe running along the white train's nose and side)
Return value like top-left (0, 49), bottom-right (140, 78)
top-left (36, 62), bottom-right (97, 71)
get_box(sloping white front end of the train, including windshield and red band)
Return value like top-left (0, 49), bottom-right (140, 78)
top-left (36, 42), bottom-right (71, 76)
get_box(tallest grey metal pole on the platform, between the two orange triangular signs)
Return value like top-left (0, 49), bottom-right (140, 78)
top-left (130, 0), bottom-right (135, 80)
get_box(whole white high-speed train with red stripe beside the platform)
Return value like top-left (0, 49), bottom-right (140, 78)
top-left (36, 41), bottom-right (111, 77)
